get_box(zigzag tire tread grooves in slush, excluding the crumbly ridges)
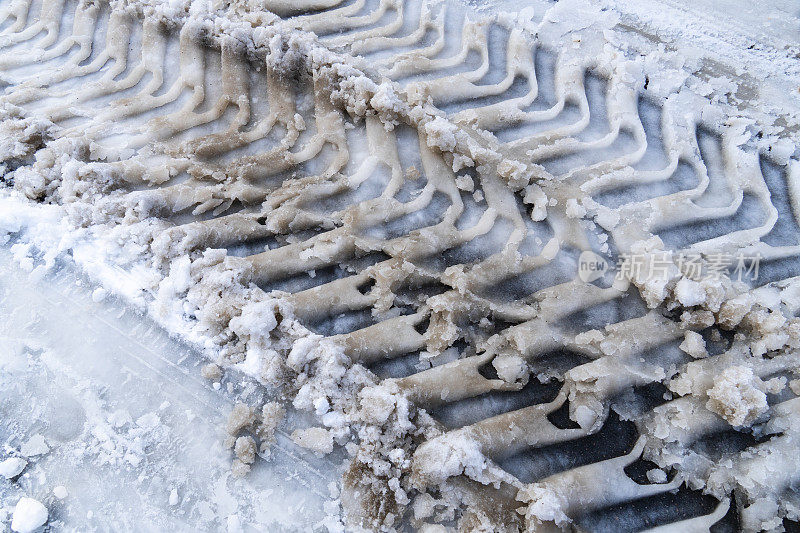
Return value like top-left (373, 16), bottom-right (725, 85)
top-left (0, 0), bottom-right (800, 531)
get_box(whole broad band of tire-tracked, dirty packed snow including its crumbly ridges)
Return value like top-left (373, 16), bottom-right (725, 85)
top-left (0, 0), bottom-right (800, 530)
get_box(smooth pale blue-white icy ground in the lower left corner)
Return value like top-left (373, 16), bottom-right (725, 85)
top-left (0, 250), bottom-right (338, 531)
